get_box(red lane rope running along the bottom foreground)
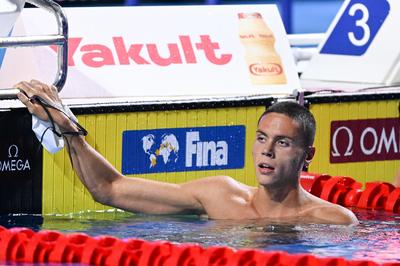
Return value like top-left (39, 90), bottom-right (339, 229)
top-left (0, 226), bottom-right (400, 266)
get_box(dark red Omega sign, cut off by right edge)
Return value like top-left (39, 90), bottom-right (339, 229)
top-left (330, 118), bottom-right (400, 163)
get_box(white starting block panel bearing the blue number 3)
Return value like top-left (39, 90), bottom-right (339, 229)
top-left (302, 0), bottom-right (400, 85)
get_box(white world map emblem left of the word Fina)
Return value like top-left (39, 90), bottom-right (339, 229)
top-left (141, 134), bottom-right (179, 168)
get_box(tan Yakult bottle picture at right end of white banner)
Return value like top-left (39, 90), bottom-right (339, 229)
top-left (238, 12), bottom-right (286, 85)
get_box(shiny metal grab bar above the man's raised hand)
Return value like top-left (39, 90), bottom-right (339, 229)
top-left (0, 0), bottom-right (68, 100)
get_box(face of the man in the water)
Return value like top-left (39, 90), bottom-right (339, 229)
top-left (253, 113), bottom-right (306, 187)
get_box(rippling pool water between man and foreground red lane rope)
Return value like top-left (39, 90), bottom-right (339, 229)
top-left (0, 210), bottom-right (400, 265)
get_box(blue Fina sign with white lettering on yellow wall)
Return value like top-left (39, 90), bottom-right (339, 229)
top-left (122, 125), bottom-right (246, 174)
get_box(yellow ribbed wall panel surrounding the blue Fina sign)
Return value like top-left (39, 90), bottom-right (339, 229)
top-left (43, 106), bottom-right (265, 214)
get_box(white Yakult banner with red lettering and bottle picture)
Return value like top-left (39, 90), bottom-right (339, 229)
top-left (0, 5), bottom-right (300, 98)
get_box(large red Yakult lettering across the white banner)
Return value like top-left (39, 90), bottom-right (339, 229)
top-left (52, 35), bottom-right (232, 68)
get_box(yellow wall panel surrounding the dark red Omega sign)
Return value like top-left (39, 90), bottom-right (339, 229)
top-left (310, 100), bottom-right (400, 183)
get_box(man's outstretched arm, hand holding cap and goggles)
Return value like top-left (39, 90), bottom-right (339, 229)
top-left (15, 80), bottom-right (204, 214)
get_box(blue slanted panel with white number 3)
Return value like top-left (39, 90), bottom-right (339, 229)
top-left (320, 0), bottom-right (390, 56)
